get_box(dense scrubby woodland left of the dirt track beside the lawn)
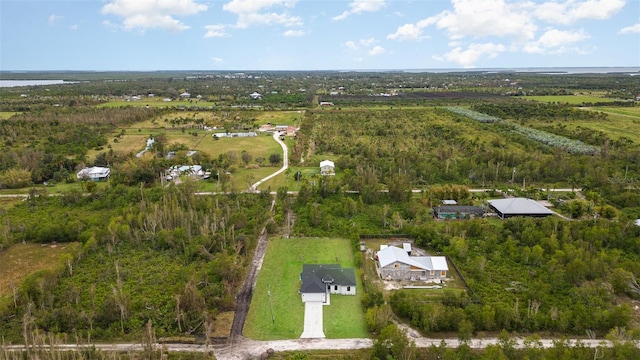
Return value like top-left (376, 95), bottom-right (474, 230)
top-left (0, 186), bottom-right (271, 341)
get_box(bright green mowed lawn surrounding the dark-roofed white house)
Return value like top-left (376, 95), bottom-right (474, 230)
top-left (244, 238), bottom-right (369, 340)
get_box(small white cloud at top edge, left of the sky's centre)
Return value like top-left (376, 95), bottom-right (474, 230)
top-left (222, 0), bottom-right (303, 29)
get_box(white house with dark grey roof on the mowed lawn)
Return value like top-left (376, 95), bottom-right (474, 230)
top-left (300, 264), bottom-right (356, 305)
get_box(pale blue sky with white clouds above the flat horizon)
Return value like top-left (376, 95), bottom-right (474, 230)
top-left (0, 0), bottom-right (640, 71)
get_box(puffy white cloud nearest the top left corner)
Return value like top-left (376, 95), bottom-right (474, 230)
top-left (102, 0), bottom-right (207, 31)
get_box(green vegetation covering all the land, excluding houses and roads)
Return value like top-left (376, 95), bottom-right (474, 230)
top-left (0, 72), bottom-right (640, 359)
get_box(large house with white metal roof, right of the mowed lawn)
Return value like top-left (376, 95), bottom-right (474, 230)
top-left (376, 246), bottom-right (449, 281)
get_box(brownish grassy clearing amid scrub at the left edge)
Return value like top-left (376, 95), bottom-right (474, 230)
top-left (0, 243), bottom-right (80, 310)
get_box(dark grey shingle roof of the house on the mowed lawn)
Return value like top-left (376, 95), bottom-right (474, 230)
top-left (300, 264), bottom-right (356, 293)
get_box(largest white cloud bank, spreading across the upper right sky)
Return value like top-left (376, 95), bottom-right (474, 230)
top-left (387, 0), bottom-right (628, 67)
